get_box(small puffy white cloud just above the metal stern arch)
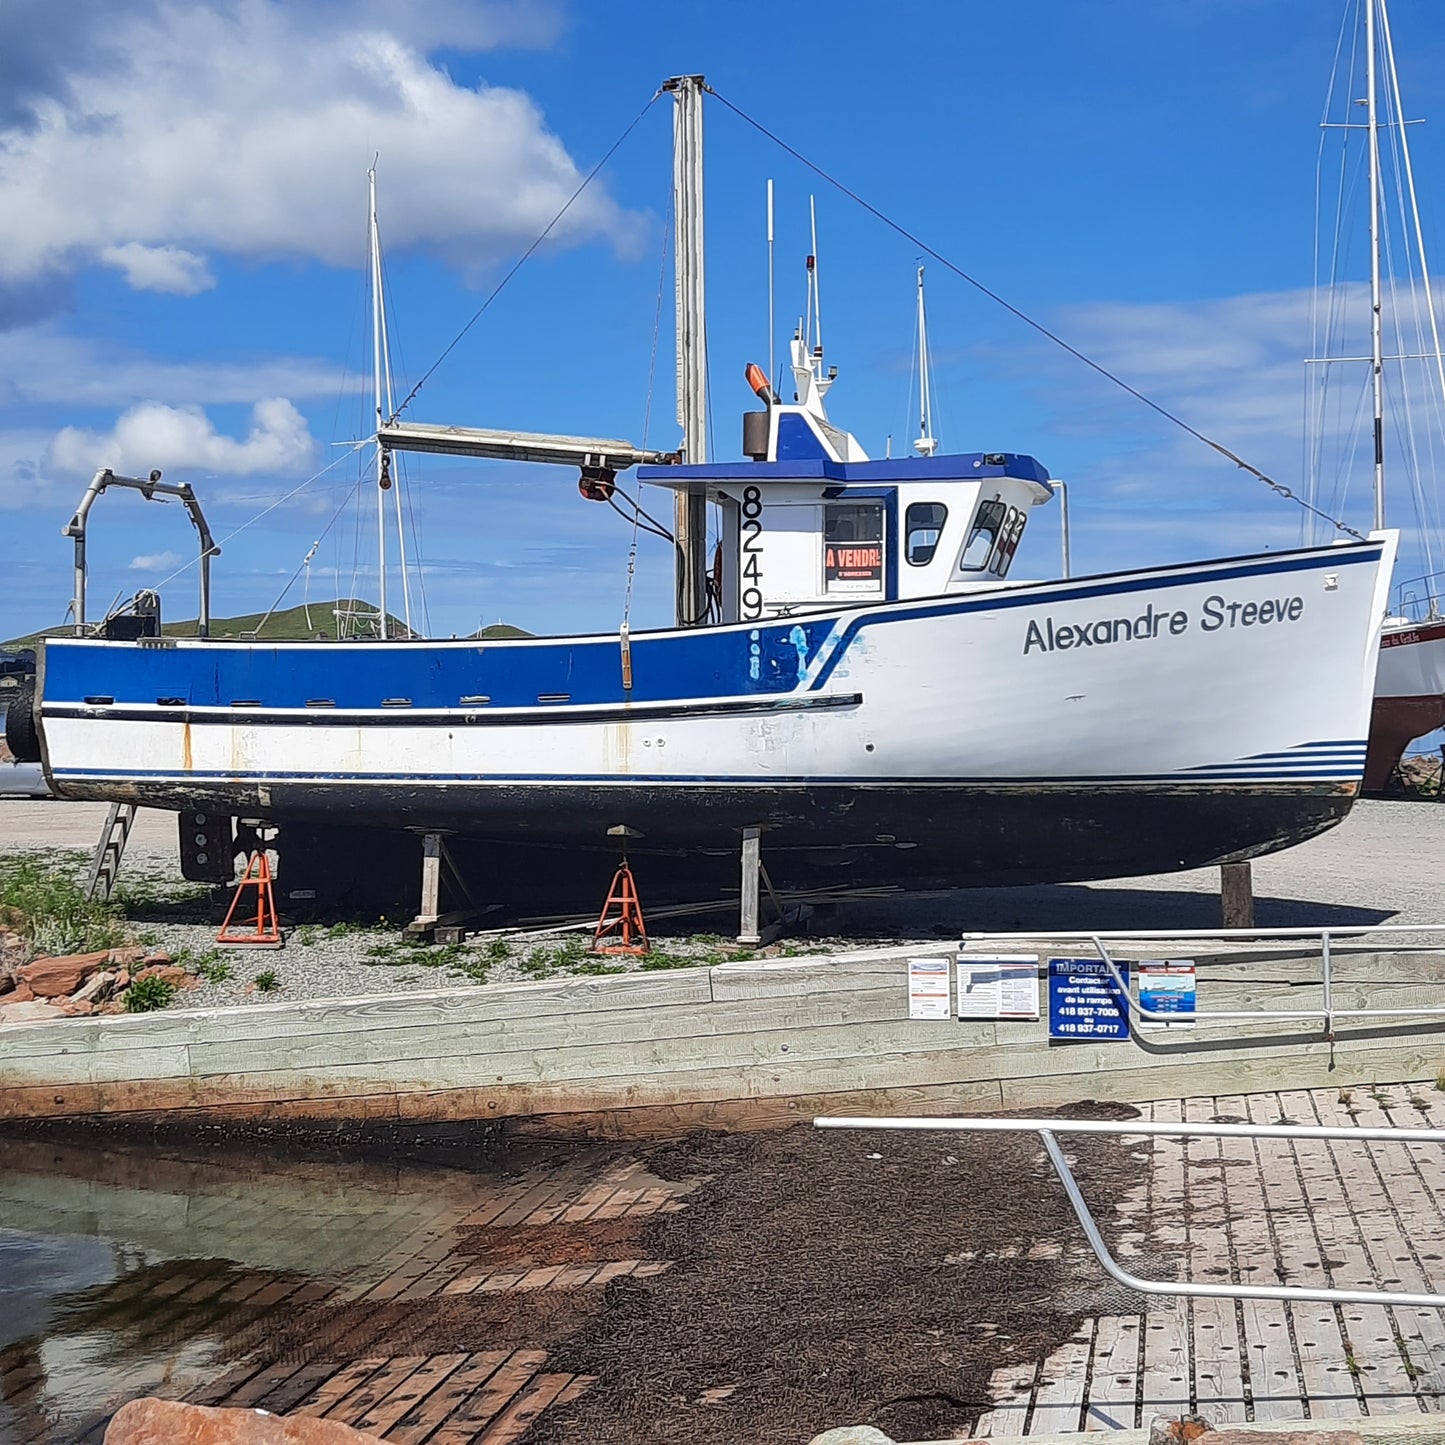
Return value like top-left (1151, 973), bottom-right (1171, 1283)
top-left (48, 396), bottom-right (316, 477)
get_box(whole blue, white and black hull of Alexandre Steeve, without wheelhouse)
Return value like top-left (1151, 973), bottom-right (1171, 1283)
top-left (31, 535), bottom-right (1393, 883)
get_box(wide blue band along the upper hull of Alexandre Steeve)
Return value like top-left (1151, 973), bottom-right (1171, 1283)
top-left (42, 543), bottom-right (1383, 715)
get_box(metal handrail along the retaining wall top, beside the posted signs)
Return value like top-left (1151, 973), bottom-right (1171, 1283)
top-left (962, 923), bottom-right (1445, 1039)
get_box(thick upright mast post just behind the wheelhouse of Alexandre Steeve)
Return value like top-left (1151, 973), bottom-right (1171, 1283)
top-left (663, 75), bottom-right (708, 627)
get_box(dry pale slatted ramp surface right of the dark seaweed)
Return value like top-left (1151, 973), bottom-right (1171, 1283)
top-left (977, 1085), bottom-right (1445, 1435)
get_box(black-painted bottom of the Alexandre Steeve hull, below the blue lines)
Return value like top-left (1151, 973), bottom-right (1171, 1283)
top-left (64, 782), bottom-right (1355, 906)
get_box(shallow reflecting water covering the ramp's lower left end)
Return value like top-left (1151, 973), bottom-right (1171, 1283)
top-left (0, 1137), bottom-right (558, 1445)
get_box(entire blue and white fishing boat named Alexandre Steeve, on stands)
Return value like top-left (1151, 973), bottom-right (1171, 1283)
top-left (5, 77), bottom-right (1394, 897)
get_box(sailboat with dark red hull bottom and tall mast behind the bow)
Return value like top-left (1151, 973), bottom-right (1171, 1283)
top-left (1314, 0), bottom-right (1445, 792)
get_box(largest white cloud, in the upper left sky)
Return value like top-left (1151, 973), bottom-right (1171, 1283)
top-left (0, 0), bottom-right (636, 302)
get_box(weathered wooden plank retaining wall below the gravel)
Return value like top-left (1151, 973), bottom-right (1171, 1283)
top-left (0, 946), bottom-right (1445, 1137)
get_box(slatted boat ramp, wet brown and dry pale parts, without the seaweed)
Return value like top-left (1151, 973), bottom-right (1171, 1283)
top-left (8, 1084), bottom-right (1445, 1445)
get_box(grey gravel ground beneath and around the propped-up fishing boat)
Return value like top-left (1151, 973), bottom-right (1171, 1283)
top-left (0, 799), bottom-right (1445, 1007)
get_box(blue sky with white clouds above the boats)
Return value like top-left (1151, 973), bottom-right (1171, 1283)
top-left (0, 0), bottom-right (1445, 636)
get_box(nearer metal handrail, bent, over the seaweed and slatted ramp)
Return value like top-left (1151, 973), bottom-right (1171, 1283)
top-left (814, 1115), bottom-right (1445, 1309)
